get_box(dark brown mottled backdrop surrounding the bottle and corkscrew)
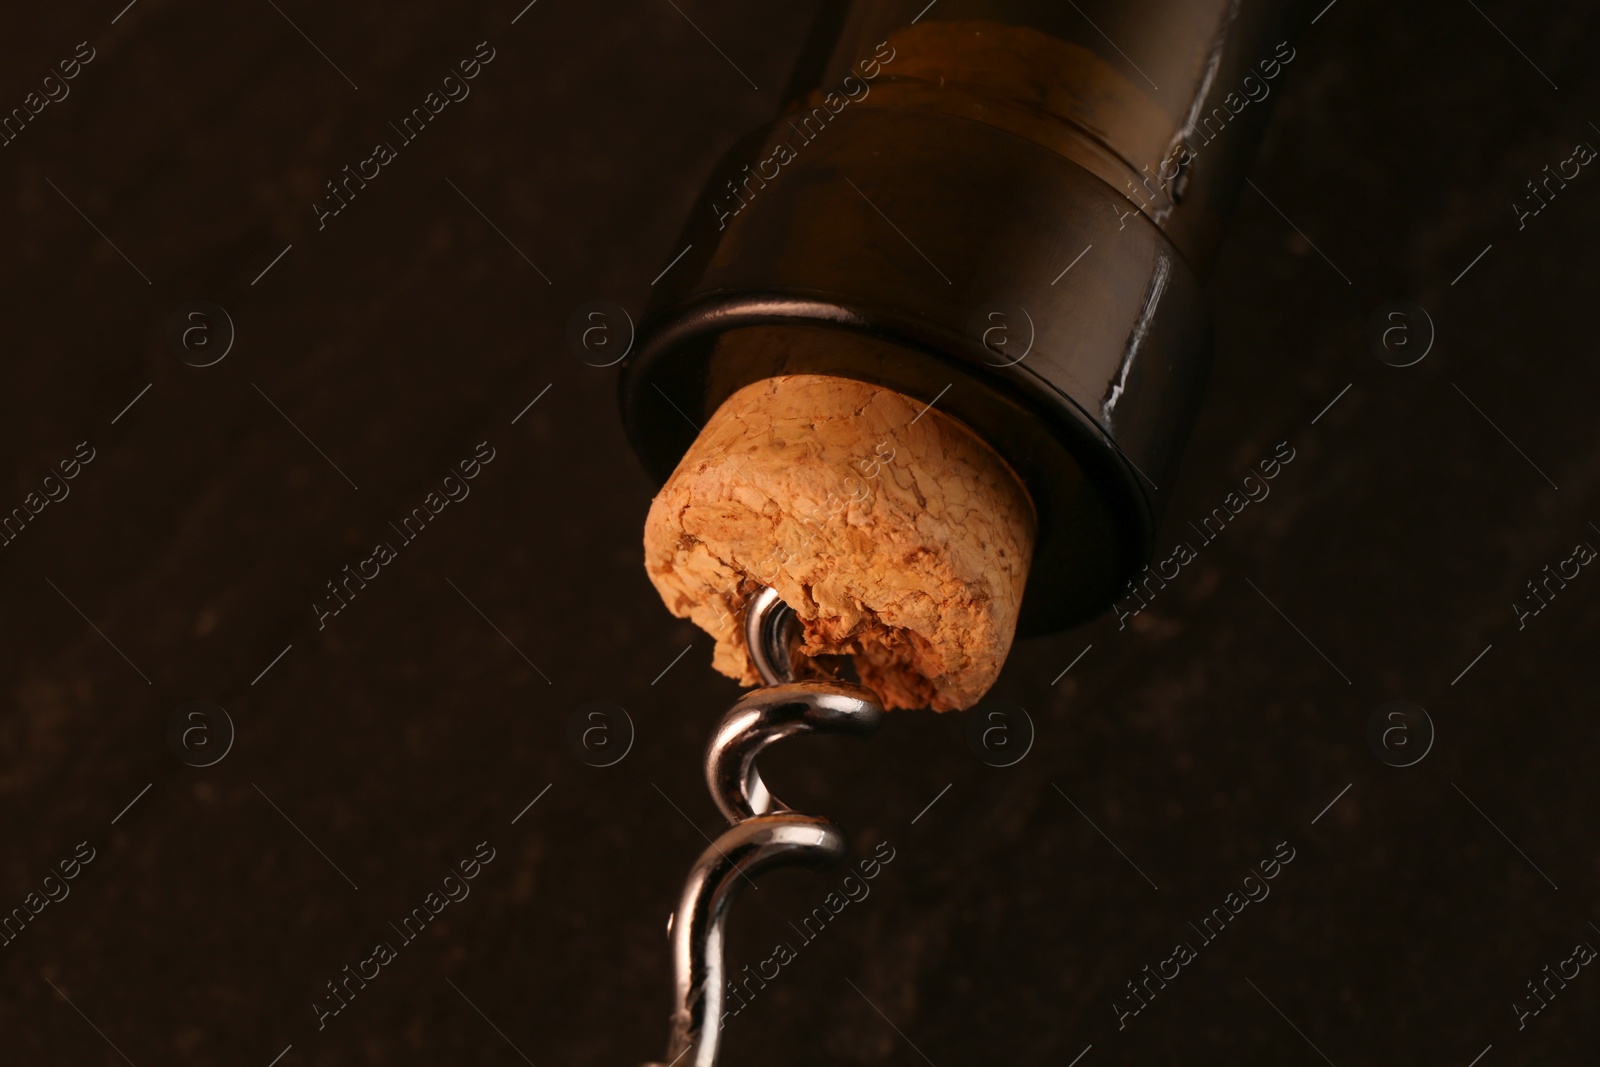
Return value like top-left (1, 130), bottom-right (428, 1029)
top-left (0, 0), bottom-right (1600, 1067)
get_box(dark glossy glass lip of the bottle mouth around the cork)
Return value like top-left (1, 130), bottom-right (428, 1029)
top-left (619, 293), bottom-right (1155, 637)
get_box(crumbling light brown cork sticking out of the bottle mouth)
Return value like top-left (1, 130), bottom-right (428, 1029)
top-left (645, 374), bottom-right (1037, 712)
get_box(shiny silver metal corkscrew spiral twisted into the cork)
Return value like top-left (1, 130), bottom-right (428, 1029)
top-left (648, 589), bottom-right (883, 1067)
